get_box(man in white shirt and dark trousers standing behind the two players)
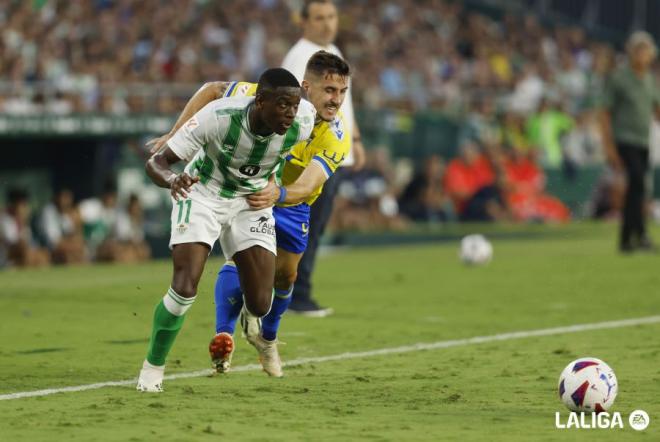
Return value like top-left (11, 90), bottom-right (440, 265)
top-left (282, 0), bottom-right (365, 317)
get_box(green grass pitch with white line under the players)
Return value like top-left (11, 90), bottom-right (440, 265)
top-left (0, 225), bottom-right (660, 441)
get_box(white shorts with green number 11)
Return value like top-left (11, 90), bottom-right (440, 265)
top-left (170, 187), bottom-right (277, 259)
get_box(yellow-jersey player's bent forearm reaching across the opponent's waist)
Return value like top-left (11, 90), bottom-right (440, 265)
top-left (247, 161), bottom-right (328, 210)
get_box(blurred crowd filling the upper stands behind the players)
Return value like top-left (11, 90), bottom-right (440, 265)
top-left (0, 0), bottom-right (628, 114)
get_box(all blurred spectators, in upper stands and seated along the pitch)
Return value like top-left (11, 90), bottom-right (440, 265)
top-left (0, 0), bottom-right (656, 265)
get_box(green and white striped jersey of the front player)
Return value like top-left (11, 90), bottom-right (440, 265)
top-left (167, 97), bottom-right (316, 198)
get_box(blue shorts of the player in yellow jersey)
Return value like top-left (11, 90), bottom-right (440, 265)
top-left (273, 203), bottom-right (309, 254)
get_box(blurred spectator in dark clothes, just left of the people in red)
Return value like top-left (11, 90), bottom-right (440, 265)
top-left (399, 155), bottom-right (448, 222)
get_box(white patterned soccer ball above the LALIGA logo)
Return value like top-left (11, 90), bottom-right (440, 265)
top-left (559, 358), bottom-right (619, 413)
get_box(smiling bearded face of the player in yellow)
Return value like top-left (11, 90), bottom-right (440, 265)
top-left (303, 74), bottom-right (348, 121)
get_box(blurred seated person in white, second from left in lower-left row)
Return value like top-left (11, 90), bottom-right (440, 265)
top-left (39, 189), bottom-right (85, 264)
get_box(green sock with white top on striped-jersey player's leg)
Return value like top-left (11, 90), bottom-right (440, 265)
top-left (147, 288), bottom-right (195, 366)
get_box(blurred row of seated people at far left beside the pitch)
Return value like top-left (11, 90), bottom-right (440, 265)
top-left (0, 185), bottom-right (151, 268)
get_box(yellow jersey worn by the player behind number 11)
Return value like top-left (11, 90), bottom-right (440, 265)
top-left (223, 81), bottom-right (351, 206)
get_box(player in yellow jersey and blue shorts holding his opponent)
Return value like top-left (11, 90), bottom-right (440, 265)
top-left (150, 51), bottom-right (350, 377)
